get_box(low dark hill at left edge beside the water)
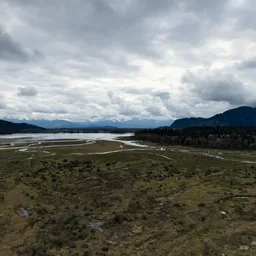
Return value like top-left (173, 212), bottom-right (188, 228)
top-left (0, 120), bottom-right (45, 134)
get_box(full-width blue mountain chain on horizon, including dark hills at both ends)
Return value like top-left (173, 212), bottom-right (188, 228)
top-left (0, 106), bottom-right (256, 134)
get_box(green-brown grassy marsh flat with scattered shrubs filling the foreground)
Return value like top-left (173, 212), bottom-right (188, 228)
top-left (0, 141), bottom-right (256, 256)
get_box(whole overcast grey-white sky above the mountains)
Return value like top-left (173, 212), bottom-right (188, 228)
top-left (0, 0), bottom-right (256, 121)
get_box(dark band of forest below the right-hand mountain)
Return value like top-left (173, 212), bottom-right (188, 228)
top-left (135, 127), bottom-right (256, 149)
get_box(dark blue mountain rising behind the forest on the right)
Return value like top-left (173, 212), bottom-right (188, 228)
top-left (171, 107), bottom-right (256, 128)
